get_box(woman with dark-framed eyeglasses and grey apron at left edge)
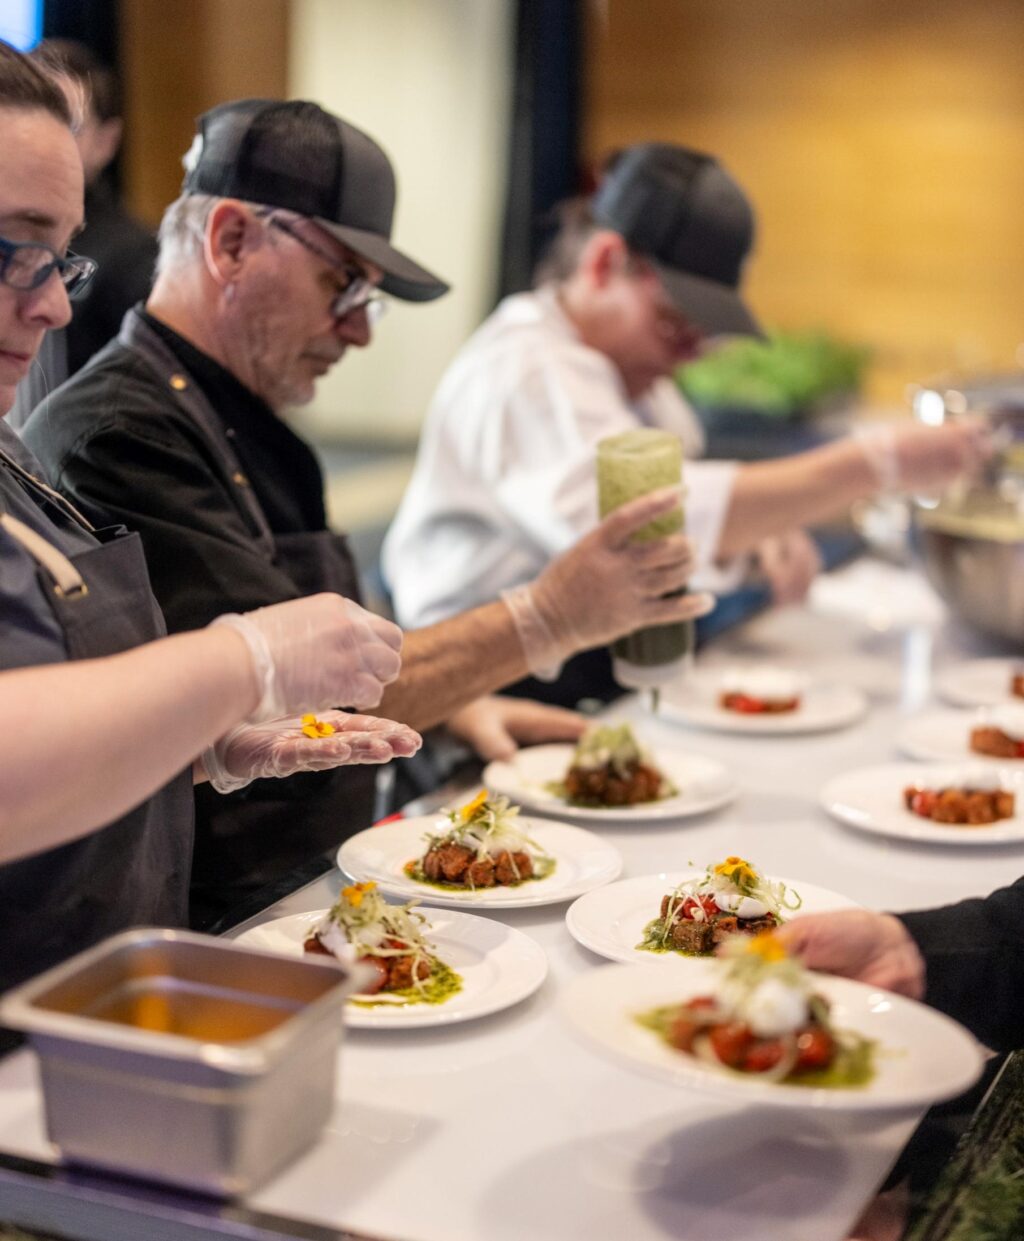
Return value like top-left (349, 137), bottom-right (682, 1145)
top-left (0, 43), bottom-right (418, 989)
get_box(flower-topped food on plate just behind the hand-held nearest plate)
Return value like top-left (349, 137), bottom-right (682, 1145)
top-left (637, 856), bottom-right (802, 957)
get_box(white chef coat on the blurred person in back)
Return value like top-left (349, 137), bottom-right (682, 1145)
top-left (382, 288), bottom-right (736, 629)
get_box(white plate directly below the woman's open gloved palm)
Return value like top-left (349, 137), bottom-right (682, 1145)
top-left (338, 814), bottom-right (622, 910)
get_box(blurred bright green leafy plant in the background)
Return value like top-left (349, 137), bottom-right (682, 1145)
top-left (676, 331), bottom-right (871, 419)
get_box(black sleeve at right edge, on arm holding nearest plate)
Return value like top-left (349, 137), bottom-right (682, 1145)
top-left (899, 877), bottom-right (1024, 1051)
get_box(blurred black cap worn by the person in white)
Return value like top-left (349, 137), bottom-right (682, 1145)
top-left (591, 143), bottom-right (763, 336)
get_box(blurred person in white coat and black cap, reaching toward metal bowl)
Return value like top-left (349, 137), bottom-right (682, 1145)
top-left (384, 143), bottom-right (982, 701)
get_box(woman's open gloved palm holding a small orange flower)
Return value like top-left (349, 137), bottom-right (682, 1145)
top-left (201, 711), bottom-right (422, 793)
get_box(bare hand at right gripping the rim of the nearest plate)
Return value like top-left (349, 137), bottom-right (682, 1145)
top-left (777, 910), bottom-right (925, 1000)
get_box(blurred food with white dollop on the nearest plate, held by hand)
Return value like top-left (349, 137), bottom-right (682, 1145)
top-left (636, 932), bottom-right (874, 1088)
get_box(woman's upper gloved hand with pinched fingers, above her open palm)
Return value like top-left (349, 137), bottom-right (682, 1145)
top-left (211, 594), bottom-right (402, 722)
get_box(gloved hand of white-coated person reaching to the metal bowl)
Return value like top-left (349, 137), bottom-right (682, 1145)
top-left (854, 414), bottom-right (994, 494)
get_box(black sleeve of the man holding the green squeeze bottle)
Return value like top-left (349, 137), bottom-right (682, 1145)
top-left (49, 418), bottom-right (302, 633)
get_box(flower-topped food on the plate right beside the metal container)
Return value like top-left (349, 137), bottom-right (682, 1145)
top-left (303, 882), bottom-right (462, 1004)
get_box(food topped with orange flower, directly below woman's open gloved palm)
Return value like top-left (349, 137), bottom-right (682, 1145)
top-left (403, 789), bottom-right (556, 891)
